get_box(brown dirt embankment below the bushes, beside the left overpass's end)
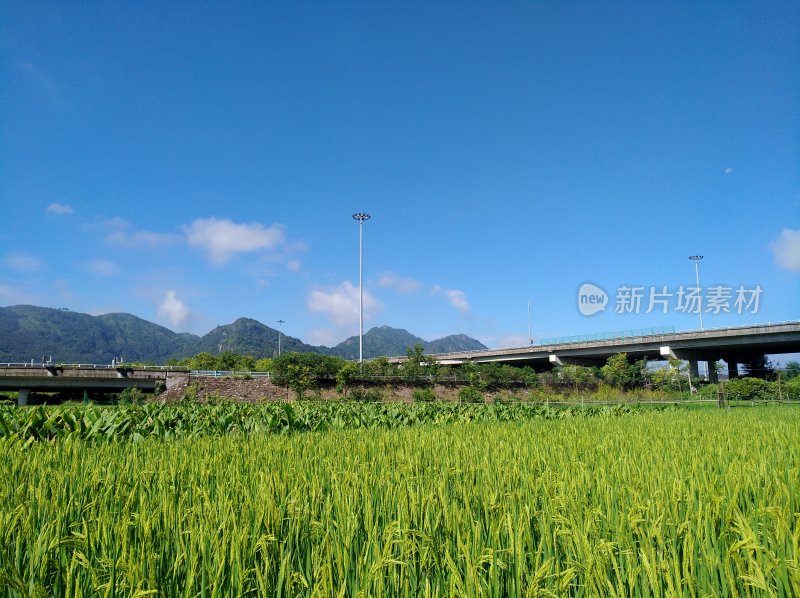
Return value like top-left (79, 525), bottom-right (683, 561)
top-left (158, 378), bottom-right (468, 403)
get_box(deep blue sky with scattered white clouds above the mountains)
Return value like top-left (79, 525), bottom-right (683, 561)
top-left (0, 0), bottom-right (800, 346)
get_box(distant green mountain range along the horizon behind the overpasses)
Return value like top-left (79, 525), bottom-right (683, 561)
top-left (0, 305), bottom-right (486, 363)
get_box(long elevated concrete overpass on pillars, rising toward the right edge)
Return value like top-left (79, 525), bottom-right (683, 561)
top-left (389, 321), bottom-right (800, 381)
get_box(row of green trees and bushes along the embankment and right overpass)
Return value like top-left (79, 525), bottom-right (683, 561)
top-left (167, 344), bottom-right (800, 398)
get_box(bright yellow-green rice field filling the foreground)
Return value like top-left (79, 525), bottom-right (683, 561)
top-left (0, 406), bottom-right (800, 597)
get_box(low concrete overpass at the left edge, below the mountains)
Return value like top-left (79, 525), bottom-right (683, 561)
top-left (0, 363), bottom-right (189, 405)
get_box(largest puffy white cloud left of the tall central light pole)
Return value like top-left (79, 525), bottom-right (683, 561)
top-left (183, 218), bottom-right (285, 265)
